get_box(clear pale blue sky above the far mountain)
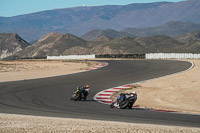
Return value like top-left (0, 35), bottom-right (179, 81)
top-left (0, 0), bottom-right (183, 17)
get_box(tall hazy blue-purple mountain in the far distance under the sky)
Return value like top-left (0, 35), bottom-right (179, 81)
top-left (0, 0), bottom-right (200, 42)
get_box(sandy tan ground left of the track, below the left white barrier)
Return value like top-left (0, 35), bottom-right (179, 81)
top-left (0, 60), bottom-right (98, 82)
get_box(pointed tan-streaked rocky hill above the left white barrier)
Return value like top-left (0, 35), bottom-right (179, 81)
top-left (11, 32), bottom-right (87, 58)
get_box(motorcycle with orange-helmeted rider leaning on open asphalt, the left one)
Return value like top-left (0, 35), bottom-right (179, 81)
top-left (71, 88), bottom-right (90, 101)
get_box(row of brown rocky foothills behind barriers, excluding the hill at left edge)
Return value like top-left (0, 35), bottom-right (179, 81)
top-left (2, 31), bottom-right (200, 59)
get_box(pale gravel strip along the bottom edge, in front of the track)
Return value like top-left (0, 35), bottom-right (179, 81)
top-left (0, 114), bottom-right (200, 133)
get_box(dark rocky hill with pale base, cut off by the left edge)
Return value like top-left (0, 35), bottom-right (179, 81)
top-left (0, 33), bottom-right (29, 59)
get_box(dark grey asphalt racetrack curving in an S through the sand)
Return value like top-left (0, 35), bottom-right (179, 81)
top-left (0, 60), bottom-right (200, 127)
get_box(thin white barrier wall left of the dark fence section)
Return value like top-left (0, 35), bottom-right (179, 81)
top-left (47, 55), bottom-right (95, 60)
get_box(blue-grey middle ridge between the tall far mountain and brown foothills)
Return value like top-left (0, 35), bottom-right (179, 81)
top-left (82, 21), bottom-right (200, 41)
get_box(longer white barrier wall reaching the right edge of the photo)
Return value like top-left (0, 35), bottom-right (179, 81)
top-left (145, 53), bottom-right (200, 59)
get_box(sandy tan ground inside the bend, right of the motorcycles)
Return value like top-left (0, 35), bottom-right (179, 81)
top-left (112, 60), bottom-right (200, 114)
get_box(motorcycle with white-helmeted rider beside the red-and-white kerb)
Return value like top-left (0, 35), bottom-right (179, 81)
top-left (110, 94), bottom-right (137, 109)
